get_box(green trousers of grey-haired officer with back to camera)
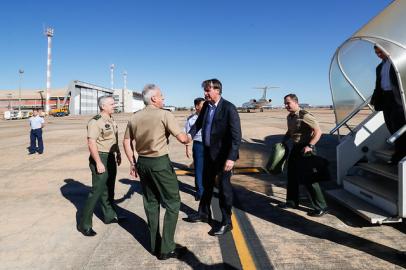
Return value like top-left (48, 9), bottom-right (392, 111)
top-left (137, 155), bottom-right (180, 254)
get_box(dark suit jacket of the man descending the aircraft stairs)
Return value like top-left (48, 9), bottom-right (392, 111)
top-left (370, 60), bottom-right (402, 111)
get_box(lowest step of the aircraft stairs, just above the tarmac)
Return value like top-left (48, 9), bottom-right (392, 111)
top-left (325, 189), bottom-right (402, 224)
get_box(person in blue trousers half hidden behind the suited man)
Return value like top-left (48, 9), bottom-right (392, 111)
top-left (185, 98), bottom-right (208, 201)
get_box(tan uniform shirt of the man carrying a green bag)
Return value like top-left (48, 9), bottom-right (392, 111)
top-left (287, 110), bottom-right (319, 143)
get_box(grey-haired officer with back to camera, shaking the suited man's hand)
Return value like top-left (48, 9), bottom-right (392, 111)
top-left (123, 84), bottom-right (191, 260)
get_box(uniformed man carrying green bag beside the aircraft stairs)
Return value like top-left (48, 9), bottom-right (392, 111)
top-left (278, 94), bottom-right (327, 217)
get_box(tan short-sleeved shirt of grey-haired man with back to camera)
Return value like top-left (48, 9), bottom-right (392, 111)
top-left (124, 105), bottom-right (182, 157)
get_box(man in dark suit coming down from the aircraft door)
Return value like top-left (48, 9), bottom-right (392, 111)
top-left (371, 46), bottom-right (406, 165)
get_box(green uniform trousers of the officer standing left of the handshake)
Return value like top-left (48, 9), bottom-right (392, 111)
top-left (79, 152), bottom-right (117, 230)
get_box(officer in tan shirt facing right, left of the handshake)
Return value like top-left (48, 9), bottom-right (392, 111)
top-left (78, 96), bottom-right (123, 236)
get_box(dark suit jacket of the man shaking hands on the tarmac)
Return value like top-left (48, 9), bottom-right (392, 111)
top-left (189, 98), bottom-right (241, 163)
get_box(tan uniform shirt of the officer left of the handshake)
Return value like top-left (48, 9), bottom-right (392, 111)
top-left (87, 114), bottom-right (119, 153)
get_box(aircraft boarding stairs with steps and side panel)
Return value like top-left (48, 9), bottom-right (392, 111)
top-left (326, 114), bottom-right (406, 224)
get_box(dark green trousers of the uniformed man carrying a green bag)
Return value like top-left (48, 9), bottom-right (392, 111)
top-left (286, 144), bottom-right (327, 210)
